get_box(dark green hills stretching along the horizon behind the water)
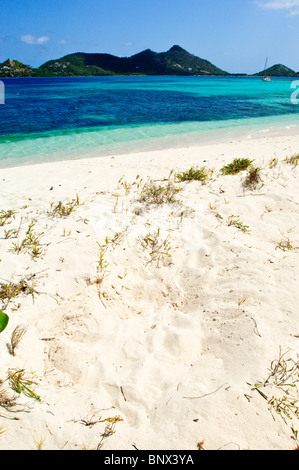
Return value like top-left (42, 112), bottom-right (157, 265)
top-left (0, 45), bottom-right (299, 77)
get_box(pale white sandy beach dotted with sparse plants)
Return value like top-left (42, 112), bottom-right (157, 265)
top-left (0, 136), bottom-right (299, 450)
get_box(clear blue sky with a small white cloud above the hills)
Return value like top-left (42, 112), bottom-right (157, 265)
top-left (0, 0), bottom-right (299, 73)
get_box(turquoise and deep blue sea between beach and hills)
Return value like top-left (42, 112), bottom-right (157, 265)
top-left (0, 77), bottom-right (299, 167)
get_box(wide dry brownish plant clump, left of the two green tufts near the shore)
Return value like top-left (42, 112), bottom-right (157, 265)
top-left (139, 181), bottom-right (181, 205)
